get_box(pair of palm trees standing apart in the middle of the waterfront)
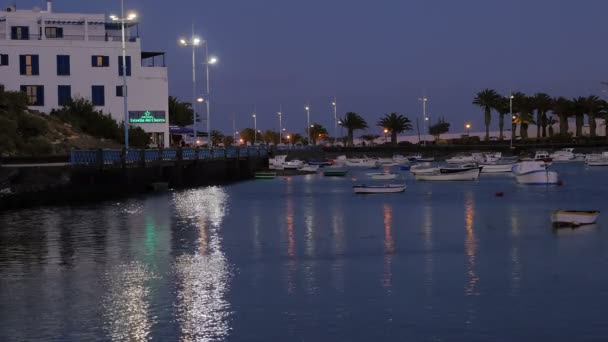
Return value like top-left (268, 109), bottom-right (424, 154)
top-left (338, 112), bottom-right (412, 146)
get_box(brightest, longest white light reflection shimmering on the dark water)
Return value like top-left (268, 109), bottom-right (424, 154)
top-left (174, 187), bottom-right (232, 341)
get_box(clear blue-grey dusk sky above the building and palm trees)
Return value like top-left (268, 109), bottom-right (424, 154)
top-left (10, 0), bottom-right (608, 134)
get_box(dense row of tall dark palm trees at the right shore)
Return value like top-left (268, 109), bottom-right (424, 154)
top-left (473, 89), bottom-right (608, 140)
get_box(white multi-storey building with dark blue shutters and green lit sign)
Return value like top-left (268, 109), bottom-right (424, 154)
top-left (0, 1), bottom-right (169, 146)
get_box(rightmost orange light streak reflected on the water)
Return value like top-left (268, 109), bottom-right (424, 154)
top-left (464, 191), bottom-right (479, 296)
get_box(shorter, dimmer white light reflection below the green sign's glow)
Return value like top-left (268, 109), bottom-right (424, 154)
top-left (103, 261), bottom-right (155, 341)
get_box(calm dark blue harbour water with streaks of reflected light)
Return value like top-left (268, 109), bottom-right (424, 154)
top-left (0, 165), bottom-right (608, 341)
